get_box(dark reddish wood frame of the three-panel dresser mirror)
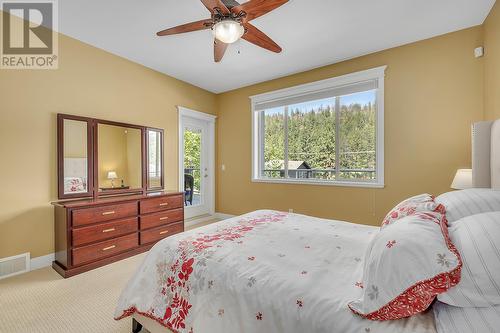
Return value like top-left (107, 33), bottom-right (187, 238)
top-left (57, 113), bottom-right (165, 199)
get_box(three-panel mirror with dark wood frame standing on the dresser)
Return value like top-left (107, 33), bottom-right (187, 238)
top-left (57, 113), bottom-right (165, 199)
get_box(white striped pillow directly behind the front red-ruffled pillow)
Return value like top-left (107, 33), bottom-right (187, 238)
top-left (438, 212), bottom-right (500, 307)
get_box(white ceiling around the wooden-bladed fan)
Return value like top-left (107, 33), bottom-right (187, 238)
top-left (59, 0), bottom-right (495, 93)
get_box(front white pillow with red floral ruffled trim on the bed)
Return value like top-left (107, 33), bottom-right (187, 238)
top-left (349, 212), bottom-right (462, 320)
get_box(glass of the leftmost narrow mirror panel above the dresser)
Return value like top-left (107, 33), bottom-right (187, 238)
top-left (63, 119), bottom-right (88, 194)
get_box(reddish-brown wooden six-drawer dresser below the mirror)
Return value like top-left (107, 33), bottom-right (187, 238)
top-left (52, 192), bottom-right (184, 278)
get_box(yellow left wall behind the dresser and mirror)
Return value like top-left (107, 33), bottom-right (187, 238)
top-left (0, 15), bottom-right (216, 258)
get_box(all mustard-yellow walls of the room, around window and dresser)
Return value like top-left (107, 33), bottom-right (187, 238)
top-left (0, 9), bottom-right (500, 258)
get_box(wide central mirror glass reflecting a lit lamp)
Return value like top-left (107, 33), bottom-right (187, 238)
top-left (97, 124), bottom-right (142, 192)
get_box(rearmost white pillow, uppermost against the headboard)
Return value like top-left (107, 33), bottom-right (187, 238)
top-left (436, 188), bottom-right (500, 225)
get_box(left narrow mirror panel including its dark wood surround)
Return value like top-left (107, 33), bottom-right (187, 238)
top-left (58, 117), bottom-right (92, 197)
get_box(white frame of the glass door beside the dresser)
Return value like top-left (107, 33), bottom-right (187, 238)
top-left (177, 106), bottom-right (217, 218)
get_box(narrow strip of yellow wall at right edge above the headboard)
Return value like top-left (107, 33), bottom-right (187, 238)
top-left (484, 1), bottom-right (500, 119)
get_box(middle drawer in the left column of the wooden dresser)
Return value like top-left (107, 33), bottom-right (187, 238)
top-left (71, 217), bottom-right (138, 246)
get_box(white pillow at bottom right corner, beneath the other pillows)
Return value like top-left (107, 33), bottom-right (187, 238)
top-left (433, 302), bottom-right (500, 333)
